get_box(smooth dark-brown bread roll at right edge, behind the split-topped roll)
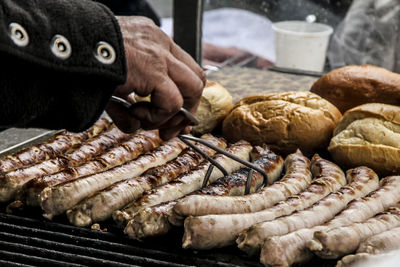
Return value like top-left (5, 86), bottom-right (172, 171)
top-left (310, 65), bottom-right (400, 113)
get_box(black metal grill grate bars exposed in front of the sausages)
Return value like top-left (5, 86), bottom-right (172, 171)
top-left (0, 213), bottom-right (260, 266)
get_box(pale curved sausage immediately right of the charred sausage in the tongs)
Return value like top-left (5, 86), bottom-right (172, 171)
top-left (174, 150), bottom-right (312, 221)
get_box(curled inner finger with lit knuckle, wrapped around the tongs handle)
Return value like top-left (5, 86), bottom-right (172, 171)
top-left (130, 78), bottom-right (183, 129)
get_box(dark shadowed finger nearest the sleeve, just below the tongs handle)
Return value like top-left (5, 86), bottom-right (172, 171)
top-left (106, 101), bottom-right (140, 133)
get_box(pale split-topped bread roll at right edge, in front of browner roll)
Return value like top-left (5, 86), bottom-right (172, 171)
top-left (328, 103), bottom-right (400, 175)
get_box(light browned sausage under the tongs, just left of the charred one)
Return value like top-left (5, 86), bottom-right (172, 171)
top-left (113, 141), bottom-right (252, 225)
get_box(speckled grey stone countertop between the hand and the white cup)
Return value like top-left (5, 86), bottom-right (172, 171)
top-left (207, 67), bottom-right (318, 103)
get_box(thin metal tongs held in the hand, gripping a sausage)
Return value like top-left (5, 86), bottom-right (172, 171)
top-left (111, 96), bottom-right (268, 195)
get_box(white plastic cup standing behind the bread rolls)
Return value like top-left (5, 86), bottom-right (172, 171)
top-left (272, 21), bottom-right (333, 72)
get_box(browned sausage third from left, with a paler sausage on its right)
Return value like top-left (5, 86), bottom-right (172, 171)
top-left (17, 131), bottom-right (162, 206)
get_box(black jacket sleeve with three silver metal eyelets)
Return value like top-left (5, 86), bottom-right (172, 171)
top-left (0, 0), bottom-right (126, 131)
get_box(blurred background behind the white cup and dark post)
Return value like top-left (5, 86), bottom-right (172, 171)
top-left (148, 0), bottom-right (400, 72)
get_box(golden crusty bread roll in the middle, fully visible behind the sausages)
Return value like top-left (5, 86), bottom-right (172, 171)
top-left (222, 92), bottom-right (341, 155)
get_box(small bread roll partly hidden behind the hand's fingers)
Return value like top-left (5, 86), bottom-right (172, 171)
top-left (193, 81), bottom-right (233, 135)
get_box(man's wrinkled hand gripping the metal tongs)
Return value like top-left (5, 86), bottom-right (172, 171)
top-left (107, 17), bottom-right (206, 139)
